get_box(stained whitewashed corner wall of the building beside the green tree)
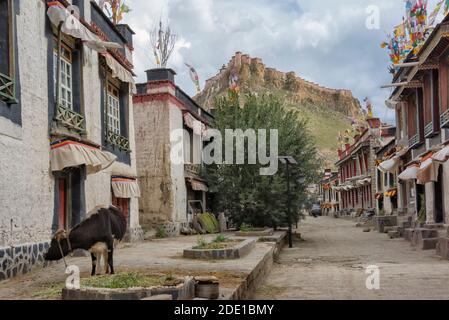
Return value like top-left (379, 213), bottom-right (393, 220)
top-left (134, 95), bottom-right (187, 236)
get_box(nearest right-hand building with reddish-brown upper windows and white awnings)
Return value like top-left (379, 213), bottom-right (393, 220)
top-left (387, 16), bottom-right (449, 224)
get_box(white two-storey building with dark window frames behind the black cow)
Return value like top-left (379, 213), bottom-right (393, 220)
top-left (0, 0), bottom-right (142, 280)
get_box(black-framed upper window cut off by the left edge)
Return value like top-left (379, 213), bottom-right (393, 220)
top-left (0, 0), bottom-right (17, 104)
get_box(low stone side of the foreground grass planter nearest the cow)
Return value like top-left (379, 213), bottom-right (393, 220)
top-left (62, 277), bottom-right (195, 300)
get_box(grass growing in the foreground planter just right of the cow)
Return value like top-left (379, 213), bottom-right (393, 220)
top-left (81, 272), bottom-right (180, 289)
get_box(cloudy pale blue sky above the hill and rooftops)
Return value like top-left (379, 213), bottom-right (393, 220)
top-left (124, 0), bottom-right (437, 122)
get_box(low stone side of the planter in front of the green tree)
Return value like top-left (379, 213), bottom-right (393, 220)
top-left (184, 239), bottom-right (257, 260)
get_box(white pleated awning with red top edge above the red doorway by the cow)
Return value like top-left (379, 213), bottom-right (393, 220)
top-left (50, 140), bottom-right (117, 174)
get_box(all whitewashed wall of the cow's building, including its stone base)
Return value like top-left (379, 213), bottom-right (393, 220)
top-left (0, 0), bottom-right (142, 280)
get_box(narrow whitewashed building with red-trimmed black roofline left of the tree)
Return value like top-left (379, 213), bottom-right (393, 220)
top-left (134, 69), bottom-right (214, 235)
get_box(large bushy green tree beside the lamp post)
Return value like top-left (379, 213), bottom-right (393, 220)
top-left (206, 93), bottom-right (319, 227)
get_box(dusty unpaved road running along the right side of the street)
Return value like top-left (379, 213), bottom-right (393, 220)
top-left (256, 217), bottom-right (449, 300)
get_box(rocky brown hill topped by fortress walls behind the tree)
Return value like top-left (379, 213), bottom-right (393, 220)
top-left (195, 52), bottom-right (361, 166)
